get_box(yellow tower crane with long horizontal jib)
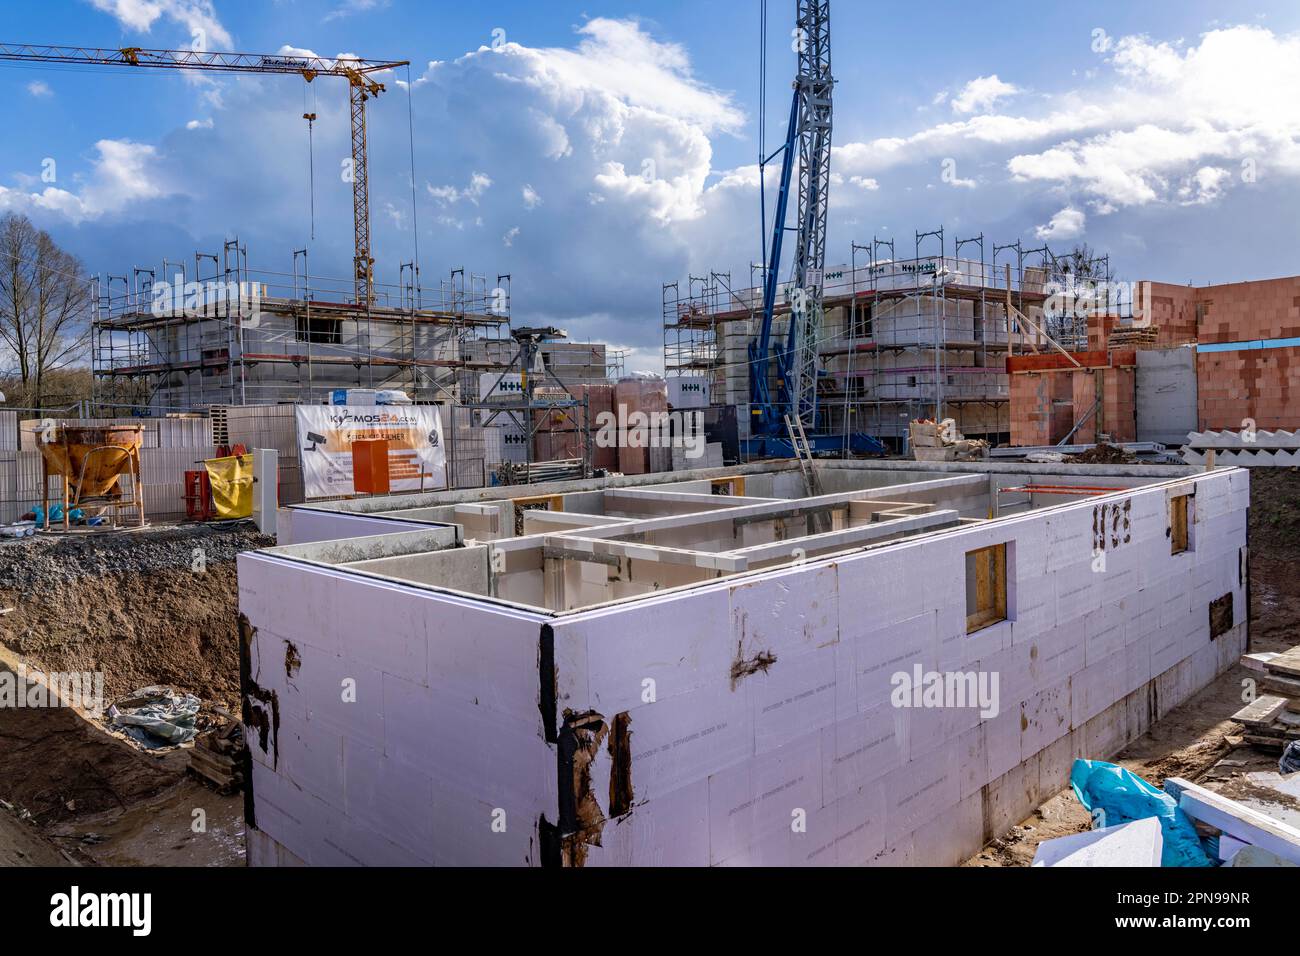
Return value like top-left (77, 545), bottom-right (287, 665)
top-left (0, 43), bottom-right (410, 307)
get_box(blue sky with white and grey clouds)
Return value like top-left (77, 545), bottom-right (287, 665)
top-left (0, 0), bottom-right (1300, 368)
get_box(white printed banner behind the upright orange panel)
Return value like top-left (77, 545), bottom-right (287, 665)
top-left (296, 405), bottom-right (447, 498)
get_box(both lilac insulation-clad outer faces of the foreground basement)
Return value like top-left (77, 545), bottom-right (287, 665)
top-left (241, 472), bottom-right (1248, 866)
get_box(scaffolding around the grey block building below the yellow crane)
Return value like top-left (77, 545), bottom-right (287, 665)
top-left (91, 239), bottom-right (511, 412)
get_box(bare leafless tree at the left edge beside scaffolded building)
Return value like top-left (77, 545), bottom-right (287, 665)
top-left (0, 212), bottom-right (91, 408)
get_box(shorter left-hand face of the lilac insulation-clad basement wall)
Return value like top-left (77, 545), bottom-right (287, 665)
top-left (239, 553), bottom-right (556, 866)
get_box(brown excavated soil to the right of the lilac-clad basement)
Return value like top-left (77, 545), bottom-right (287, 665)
top-left (965, 468), bottom-right (1300, 866)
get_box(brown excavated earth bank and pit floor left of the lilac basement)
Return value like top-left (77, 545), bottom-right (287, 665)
top-left (0, 523), bottom-right (273, 865)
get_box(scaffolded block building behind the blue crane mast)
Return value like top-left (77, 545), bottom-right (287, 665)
top-left (663, 229), bottom-right (1110, 450)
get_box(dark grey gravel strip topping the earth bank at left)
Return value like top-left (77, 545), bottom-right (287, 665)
top-left (0, 522), bottom-right (274, 596)
